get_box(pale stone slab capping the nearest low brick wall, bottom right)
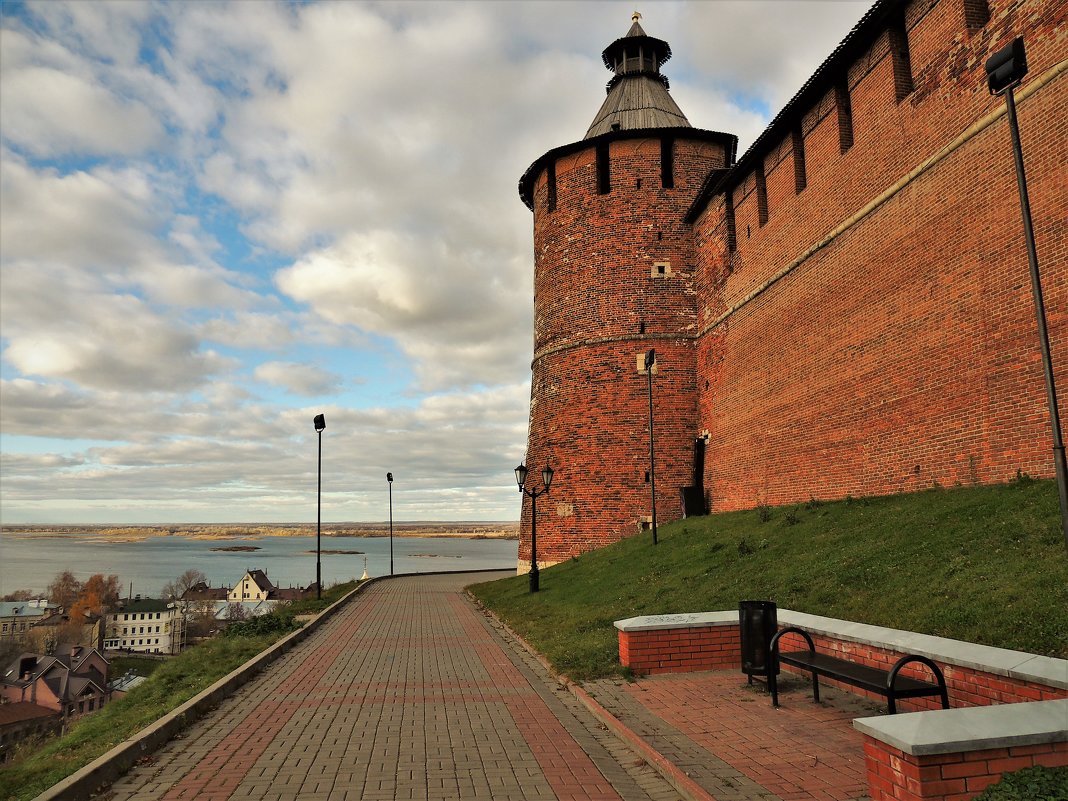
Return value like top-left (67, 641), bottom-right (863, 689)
top-left (853, 698), bottom-right (1068, 756)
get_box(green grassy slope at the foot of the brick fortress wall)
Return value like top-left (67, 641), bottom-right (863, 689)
top-left (471, 476), bottom-right (1068, 680)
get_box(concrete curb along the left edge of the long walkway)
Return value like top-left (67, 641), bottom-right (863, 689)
top-left (33, 576), bottom-right (389, 801)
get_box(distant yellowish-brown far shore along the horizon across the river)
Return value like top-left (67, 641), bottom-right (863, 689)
top-left (0, 521), bottom-right (519, 543)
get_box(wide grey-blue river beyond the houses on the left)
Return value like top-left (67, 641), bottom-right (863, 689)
top-left (0, 531), bottom-right (519, 597)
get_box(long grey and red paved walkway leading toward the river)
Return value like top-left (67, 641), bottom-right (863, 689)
top-left (111, 575), bottom-right (678, 801)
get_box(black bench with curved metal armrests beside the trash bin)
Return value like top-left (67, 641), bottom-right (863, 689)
top-left (768, 626), bottom-right (949, 714)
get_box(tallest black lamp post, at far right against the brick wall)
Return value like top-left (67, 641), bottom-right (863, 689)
top-left (986, 36), bottom-right (1068, 549)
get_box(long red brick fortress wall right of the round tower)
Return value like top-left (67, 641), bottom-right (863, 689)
top-left (695, 0), bottom-right (1068, 509)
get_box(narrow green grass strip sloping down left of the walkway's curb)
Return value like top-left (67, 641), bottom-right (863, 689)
top-left (0, 582), bottom-right (356, 801)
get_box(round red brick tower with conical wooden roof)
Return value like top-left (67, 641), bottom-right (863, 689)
top-left (519, 14), bottom-right (737, 571)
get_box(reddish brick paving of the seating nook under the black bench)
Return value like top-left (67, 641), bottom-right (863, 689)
top-left (585, 671), bottom-right (885, 801)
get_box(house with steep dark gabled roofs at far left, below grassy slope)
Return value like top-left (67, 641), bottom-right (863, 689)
top-left (0, 645), bottom-right (108, 719)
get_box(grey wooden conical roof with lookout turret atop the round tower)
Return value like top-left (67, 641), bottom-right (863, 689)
top-left (585, 11), bottom-right (692, 139)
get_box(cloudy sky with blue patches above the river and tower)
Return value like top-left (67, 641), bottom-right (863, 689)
top-left (0, 0), bottom-right (870, 525)
